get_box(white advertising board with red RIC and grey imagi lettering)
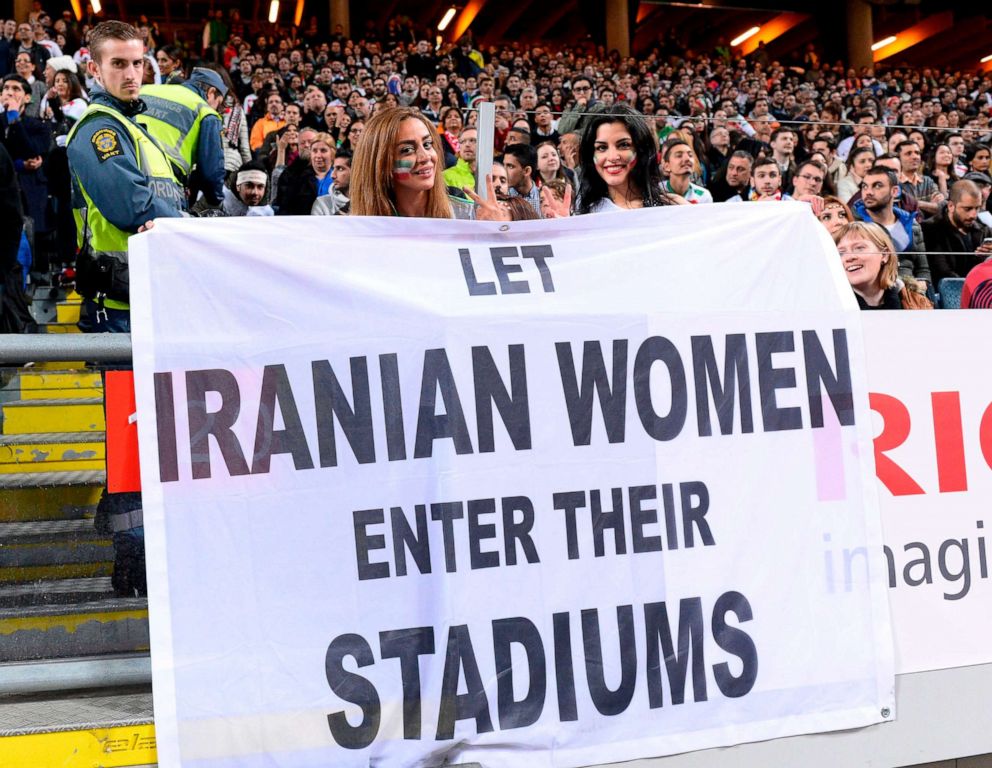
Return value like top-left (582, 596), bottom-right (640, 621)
top-left (860, 311), bottom-right (992, 673)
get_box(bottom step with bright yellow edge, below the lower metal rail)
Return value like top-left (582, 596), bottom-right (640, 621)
top-left (0, 686), bottom-right (158, 768)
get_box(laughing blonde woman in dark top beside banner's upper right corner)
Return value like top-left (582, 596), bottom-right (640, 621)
top-left (833, 221), bottom-right (933, 309)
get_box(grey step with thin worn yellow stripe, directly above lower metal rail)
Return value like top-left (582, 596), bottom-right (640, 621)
top-left (0, 592), bottom-right (149, 660)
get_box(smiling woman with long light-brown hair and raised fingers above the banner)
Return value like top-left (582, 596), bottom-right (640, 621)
top-left (351, 107), bottom-right (509, 221)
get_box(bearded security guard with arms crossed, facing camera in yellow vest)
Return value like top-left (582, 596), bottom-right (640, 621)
top-left (67, 21), bottom-right (185, 596)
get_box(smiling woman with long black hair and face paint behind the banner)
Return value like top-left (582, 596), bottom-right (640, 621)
top-left (576, 104), bottom-right (674, 213)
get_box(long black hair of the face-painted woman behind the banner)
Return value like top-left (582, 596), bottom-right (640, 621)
top-left (578, 103), bottom-right (672, 213)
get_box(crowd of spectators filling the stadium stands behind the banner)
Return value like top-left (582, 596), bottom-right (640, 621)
top-left (0, 7), bottom-right (992, 330)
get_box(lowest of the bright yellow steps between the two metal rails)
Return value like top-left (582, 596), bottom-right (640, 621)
top-left (0, 432), bottom-right (106, 473)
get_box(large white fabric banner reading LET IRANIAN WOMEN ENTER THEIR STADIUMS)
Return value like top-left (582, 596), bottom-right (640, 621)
top-left (131, 203), bottom-right (894, 768)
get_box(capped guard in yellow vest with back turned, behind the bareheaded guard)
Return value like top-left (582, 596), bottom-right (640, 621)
top-left (138, 67), bottom-right (227, 205)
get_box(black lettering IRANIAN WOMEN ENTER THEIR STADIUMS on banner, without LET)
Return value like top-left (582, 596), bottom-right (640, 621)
top-left (154, 310), bottom-right (854, 749)
